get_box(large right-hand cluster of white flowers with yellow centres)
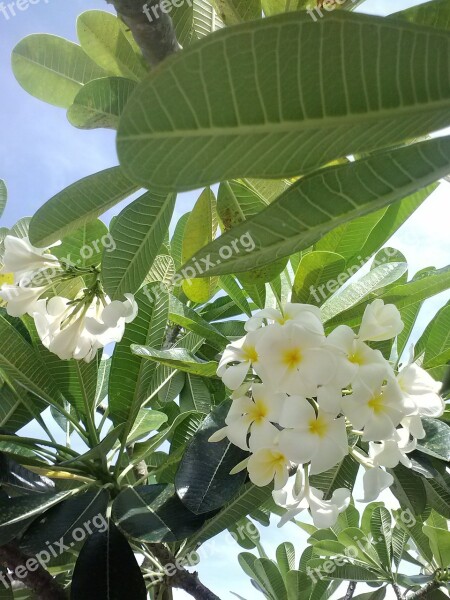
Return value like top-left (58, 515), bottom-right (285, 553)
top-left (210, 300), bottom-right (444, 527)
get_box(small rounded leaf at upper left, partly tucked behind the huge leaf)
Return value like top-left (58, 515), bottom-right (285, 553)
top-left (67, 77), bottom-right (136, 129)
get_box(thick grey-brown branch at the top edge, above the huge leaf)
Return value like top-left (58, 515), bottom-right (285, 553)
top-left (106, 0), bottom-right (181, 67)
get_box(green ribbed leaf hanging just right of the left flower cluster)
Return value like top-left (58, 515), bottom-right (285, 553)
top-left (102, 192), bottom-right (176, 299)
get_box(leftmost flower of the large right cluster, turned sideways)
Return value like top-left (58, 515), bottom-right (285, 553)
top-left (217, 330), bottom-right (263, 390)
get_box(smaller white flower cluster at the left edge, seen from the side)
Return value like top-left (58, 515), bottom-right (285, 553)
top-left (0, 235), bottom-right (138, 362)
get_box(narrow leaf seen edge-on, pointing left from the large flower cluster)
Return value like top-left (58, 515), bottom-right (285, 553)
top-left (131, 344), bottom-right (217, 377)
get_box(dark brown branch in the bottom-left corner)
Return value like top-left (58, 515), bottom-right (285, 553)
top-left (0, 544), bottom-right (67, 600)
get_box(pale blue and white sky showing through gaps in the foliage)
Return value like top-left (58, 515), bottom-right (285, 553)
top-left (0, 0), bottom-right (450, 600)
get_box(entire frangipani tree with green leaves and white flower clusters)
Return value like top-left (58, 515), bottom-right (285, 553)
top-left (0, 0), bottom-right (450, 600)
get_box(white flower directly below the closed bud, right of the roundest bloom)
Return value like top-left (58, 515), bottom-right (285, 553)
top-left (327, 325), bottom-right (390, 388)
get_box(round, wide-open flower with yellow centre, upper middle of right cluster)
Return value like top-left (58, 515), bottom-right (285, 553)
top-left (257, 322), bottom-right (336, 396)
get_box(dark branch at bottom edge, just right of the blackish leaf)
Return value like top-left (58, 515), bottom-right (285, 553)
top-left (148, 544), bottom-right (220, 600)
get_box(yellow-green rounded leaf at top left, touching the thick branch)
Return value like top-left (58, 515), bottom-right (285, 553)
top-left (77, 10), bottom-right (148, 81)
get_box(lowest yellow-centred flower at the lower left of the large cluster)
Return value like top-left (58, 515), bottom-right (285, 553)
top-left (247, 443), bottom-right (291, 490)
